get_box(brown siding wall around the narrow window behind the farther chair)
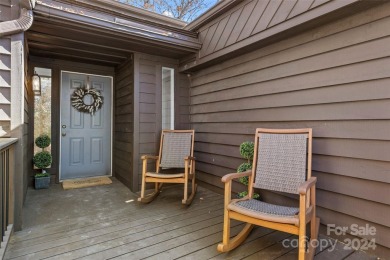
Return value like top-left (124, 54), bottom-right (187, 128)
top-left (133, 54), bottom-right (190, 191)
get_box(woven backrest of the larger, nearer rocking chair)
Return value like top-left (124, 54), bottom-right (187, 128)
top-left (252, 128), bottom-right (311, 194)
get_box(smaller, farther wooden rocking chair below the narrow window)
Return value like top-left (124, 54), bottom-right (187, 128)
top-left (138, 130), bottom-right (197, 205)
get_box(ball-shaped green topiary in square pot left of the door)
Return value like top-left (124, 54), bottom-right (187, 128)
top-left (33, 134), bottom-right (52, 189)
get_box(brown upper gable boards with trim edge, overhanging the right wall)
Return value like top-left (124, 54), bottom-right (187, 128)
top-left (180, 0), bottom-right (383, 72)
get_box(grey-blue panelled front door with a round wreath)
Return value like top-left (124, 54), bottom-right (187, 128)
top-left (60, 72), bottom-right (112, 180)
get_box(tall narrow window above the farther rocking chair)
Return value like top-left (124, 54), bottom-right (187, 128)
top-left (162, 67), bottom-right (175, 130)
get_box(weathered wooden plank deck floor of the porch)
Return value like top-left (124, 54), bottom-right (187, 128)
top-left (6, 180), bottom-right (375, 260)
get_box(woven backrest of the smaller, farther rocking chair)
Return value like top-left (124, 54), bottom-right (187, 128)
top-left (159, 130), bottom-right (194, 168)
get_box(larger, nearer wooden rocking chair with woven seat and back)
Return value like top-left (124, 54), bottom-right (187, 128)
top-left (218, 128), bottom-right (320, 259)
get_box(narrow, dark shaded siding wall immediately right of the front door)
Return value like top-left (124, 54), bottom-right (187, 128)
top-left (113, 59), bottom-right (134, 187)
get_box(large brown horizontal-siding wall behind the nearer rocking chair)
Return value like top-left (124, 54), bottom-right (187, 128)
top-left (190, 1), bottom-right (390, 253)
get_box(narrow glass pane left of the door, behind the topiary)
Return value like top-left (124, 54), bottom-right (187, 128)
top-left (34, 68), bottom-right (51, 154)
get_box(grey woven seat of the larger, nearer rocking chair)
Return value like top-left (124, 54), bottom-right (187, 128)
top-left (228, 199), bottom-right (299, 225)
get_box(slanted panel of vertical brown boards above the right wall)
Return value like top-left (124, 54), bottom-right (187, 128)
top-left (199, 0), bottom-right (329, 58)
